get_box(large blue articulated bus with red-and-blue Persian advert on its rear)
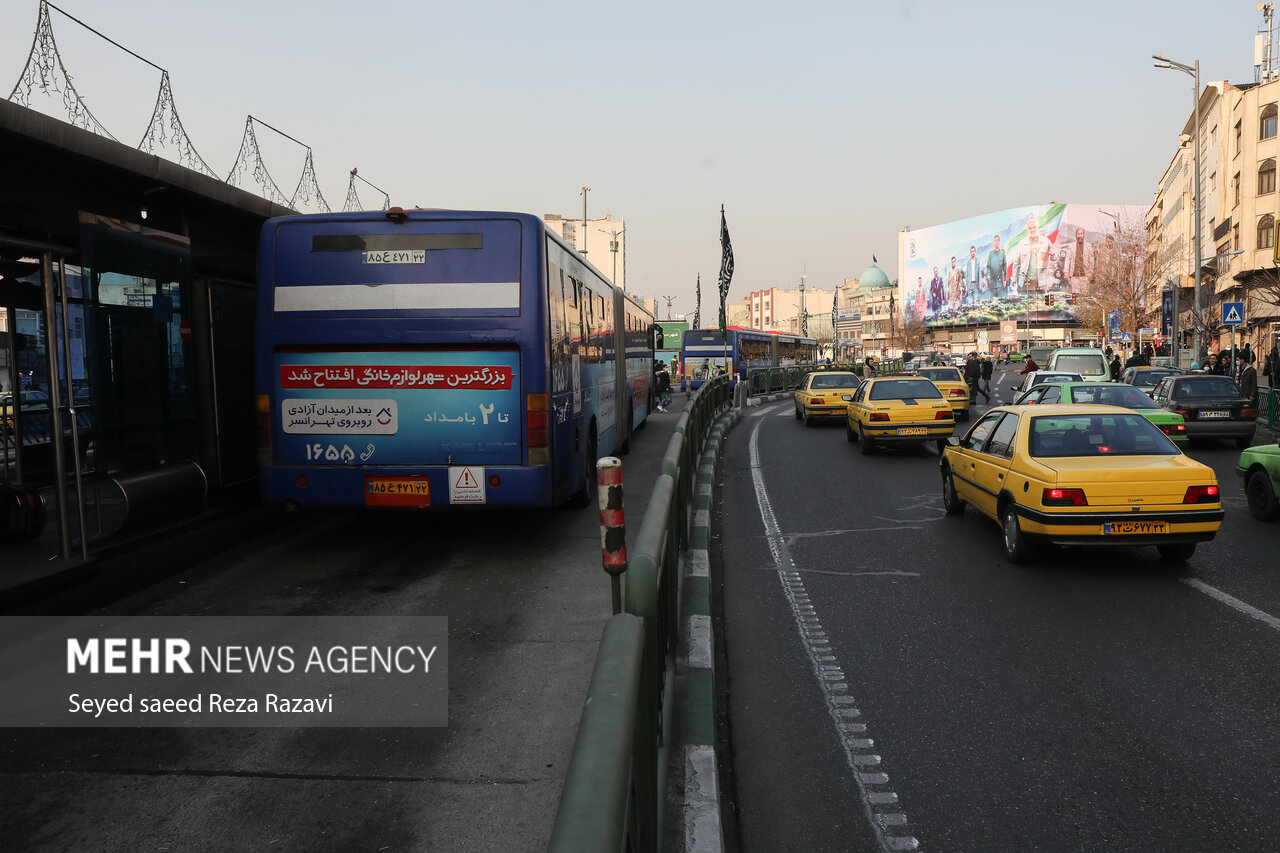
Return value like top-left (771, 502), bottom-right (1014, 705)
top-left (255, 207), bottom-right (653, 508)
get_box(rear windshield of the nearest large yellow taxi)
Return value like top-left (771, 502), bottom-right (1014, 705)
top-left (1028, 414), bottom-right (1181, 457)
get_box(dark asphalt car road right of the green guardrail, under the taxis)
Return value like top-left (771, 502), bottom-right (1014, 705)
top-left (713, 371), bottom-right (1280, 853)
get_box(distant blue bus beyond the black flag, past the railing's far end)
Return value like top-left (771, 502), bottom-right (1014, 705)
top-left (680, 325), bottom-right (818, 391)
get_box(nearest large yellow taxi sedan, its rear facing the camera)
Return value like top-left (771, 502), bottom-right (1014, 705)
top-left (941, 405), bottom-right (1222, 562)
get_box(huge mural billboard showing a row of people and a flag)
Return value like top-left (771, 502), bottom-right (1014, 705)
top-left (897, 204), bottom-right (1147, 327)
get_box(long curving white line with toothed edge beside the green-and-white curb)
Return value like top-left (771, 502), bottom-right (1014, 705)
top-left (750, 420), bottom-right (920, 853)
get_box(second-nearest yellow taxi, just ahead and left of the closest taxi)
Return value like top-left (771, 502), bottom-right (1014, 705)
top-left (845, 375), bottom-right (956, 453)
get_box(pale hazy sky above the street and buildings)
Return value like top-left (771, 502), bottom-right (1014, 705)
top-left (0, 0), bottom-right (1262, 318)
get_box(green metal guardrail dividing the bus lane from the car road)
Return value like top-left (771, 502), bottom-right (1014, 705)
top-left (548, 377), bottom-right (730, 853)
